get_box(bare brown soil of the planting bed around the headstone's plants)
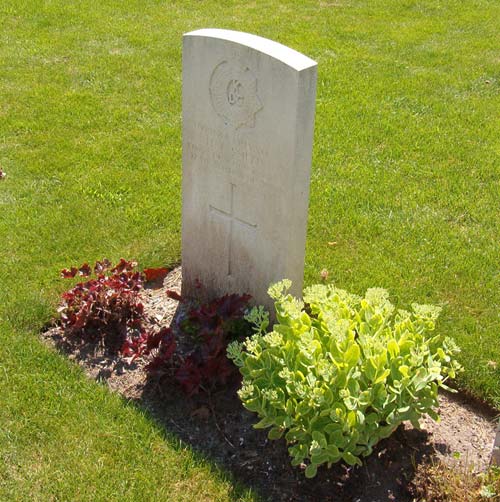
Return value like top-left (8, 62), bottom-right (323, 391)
top-left (43, 267), bottom-right (495, 501)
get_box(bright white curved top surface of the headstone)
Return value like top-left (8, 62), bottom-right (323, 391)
top-left (184, 28), bottom-right (317, 71)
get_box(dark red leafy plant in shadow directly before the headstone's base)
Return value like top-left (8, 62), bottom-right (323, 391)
top-left (148, 294), bottom-right (250, 395)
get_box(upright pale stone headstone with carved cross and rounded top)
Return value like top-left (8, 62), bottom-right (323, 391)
top-left (182, 29), bottom-right (317, 306)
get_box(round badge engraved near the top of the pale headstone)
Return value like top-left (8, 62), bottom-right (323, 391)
top-left (210, 61), bottom-right (262, 129)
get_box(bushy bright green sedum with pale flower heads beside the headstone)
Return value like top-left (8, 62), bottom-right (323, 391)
top-left (228, 280), bottom-right (460, 477)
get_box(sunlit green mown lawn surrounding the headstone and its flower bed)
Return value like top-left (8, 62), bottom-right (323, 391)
top-left (0, 0), bottom-right (500, 500)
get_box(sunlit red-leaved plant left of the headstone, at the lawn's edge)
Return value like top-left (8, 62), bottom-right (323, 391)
top-left (59, 260), bottom-right (147, 355)
